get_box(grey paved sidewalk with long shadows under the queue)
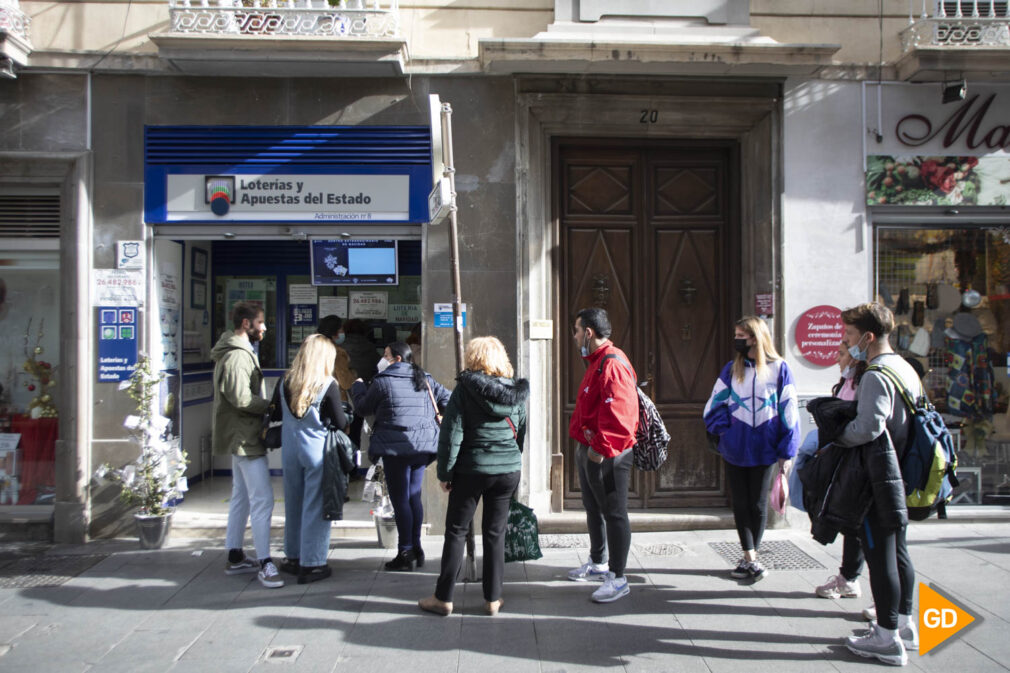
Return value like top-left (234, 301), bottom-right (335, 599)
top-left (0, 519), bottom-right (1010, 673)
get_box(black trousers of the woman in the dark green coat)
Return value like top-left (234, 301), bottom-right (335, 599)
top-left (435, 471), bottom-right (520, 601)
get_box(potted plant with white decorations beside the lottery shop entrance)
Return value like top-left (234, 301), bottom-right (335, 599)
top-left (95, 355), bottom-right (186, 549)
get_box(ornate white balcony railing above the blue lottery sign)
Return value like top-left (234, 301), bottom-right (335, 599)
top-left (167, 0), bottom-right (400, 39)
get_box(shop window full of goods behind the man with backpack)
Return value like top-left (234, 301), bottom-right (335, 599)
top-left (876, 227), bottom-right (1010, 503)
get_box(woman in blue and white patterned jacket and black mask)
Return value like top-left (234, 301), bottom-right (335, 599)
top-left (705, 316), bottom-right (800, 582)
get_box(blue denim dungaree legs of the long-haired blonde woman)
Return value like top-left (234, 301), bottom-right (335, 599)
top-left (281, 442), bottom-right (330, 567)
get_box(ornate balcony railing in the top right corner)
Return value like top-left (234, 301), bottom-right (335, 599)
top-left (901, 0), bottom-right (1010, 52)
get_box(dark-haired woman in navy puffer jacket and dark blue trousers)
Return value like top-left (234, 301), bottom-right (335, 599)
top-left (350, 342), bottom-right (449, 571)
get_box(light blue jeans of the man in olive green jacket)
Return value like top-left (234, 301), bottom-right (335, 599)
top-left (224, 456), bottom-right (274, 559)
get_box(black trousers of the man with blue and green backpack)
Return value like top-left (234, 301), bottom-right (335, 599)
top-left (860, 509), bottom-right (915, 629)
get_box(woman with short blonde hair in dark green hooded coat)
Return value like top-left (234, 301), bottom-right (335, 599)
top-left (417, 337), bottom-right (529, 615)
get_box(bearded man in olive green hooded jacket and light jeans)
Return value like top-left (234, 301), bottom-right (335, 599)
top-left (210, 301), bottom-right (284, 589)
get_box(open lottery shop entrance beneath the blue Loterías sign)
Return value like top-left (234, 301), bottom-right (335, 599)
top-left (148, 234), bottom-right (421, 519)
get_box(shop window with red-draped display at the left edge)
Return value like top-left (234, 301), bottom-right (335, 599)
top-left (0, 250), bottom-right (64, 505)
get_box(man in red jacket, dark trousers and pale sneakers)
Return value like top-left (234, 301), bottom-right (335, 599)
top-left (569, 308), bottom-right (638, 603)
